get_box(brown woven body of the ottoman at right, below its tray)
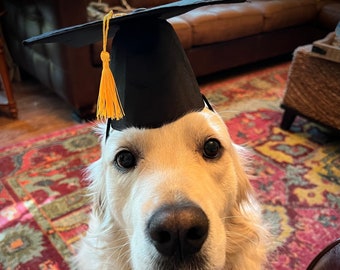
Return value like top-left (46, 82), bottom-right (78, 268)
top-left (283, 45), bottom-right (340, 129)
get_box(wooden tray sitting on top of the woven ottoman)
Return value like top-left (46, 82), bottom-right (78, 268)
top-left (311, 32), bottom-right (340, 63)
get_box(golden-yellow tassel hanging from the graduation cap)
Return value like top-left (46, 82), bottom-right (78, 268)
top-left (97, 10), bottom-right (124, 120)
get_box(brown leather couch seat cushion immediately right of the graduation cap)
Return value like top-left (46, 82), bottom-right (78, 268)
top-left (175, 3), bottom-right (263, 46)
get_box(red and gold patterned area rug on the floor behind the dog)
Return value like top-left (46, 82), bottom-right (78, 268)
top-left (0, 64), bottom-right (340, 270)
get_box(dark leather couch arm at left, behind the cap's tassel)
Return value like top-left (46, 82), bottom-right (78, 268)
top-left (2, 0), bottom-right (100, 115)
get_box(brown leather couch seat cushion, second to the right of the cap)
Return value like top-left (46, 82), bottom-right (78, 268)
top-left (251, 0), bottom-right (317, 32)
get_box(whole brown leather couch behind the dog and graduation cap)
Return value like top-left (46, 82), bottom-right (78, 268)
top-left (2, 0), bottom-right (340, 118)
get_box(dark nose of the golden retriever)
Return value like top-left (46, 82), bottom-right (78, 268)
top-left (147, 203), bottom-right (209, 260)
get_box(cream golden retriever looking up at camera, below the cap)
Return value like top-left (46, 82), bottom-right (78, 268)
top-left (76, 108), bottom-right (269, 270)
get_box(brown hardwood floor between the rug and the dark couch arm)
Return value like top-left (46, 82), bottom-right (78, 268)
top-left (0, 78), bottom-right (79, 148)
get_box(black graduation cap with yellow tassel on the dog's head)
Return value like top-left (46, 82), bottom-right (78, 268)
top-left (24, 0), bottom-right (244, 134)
